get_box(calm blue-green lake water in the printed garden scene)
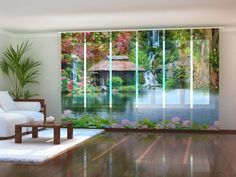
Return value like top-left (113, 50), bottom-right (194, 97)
top-left (62, 88), bottom-right (218, 124)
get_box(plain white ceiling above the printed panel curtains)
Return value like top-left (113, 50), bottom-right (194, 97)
top-left (0, 0), bottom-right (236, 33)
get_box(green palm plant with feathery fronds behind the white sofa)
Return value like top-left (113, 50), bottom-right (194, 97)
top-left (0, 41), bottom-right (41, 99)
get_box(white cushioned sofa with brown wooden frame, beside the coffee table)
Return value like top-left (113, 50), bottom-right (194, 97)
top-left (0, 91), bottom-right (46, 139)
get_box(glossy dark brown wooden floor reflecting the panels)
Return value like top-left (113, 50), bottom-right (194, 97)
top-left (0, 132), bottom-right (236, 177)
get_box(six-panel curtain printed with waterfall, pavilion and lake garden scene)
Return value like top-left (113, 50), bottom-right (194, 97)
top-left (61, 29), bottom-right (219, 130)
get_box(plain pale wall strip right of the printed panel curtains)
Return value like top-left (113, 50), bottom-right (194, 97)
top-left (220, 28), bottom-right (236, 130)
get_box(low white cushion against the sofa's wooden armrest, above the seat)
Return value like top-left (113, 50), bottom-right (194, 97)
top-left (15, 101), bottom-right (41, 112)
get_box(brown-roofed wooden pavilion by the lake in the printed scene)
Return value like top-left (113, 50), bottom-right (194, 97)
top-left (88, 55), bottom-right (145, 86)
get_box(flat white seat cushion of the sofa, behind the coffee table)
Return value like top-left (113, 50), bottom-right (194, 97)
top-left (8, 110), bottom-right (44, 121)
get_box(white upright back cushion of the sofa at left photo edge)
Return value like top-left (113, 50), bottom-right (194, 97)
top-left (0, 91), bottom-right (16, 111)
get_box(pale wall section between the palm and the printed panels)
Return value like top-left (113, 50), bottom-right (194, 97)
top-left (11, 33), bottom-right (61, 118)
